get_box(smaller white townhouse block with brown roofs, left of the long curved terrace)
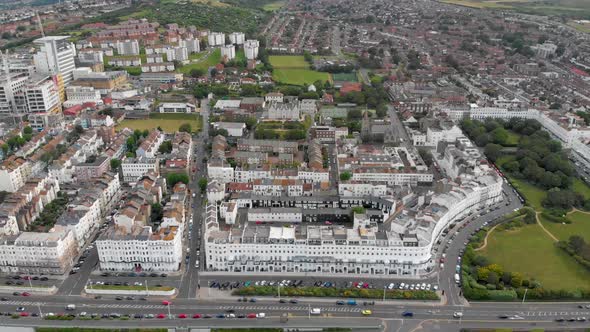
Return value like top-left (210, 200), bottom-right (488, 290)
top-left (96, 174), bottom-right (187, 272)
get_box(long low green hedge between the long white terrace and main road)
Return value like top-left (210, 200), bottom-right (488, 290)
top-left (232, 286), bottom-right (439, 300)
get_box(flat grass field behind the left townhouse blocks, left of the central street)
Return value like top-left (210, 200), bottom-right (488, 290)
top-left (117, 113), bottom-right (202, 133)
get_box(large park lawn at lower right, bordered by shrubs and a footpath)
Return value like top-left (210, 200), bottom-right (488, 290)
top-left (481, 223), bottom-right (590, 290)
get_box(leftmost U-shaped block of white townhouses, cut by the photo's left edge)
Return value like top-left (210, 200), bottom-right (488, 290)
top-left (0, 174), bottom-right (120, 275)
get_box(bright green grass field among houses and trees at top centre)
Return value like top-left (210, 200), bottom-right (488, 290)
top-left (270, 55), bottom-right (331, 85)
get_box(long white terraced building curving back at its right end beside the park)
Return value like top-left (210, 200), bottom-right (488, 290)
top-left (205, 166), bottom-right (502, 276)
